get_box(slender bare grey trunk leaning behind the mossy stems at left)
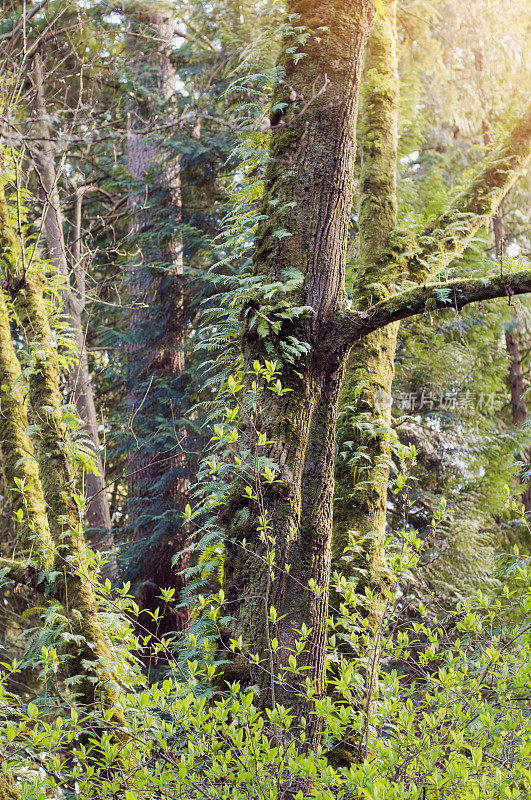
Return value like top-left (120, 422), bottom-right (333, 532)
top-left (31, 53), bottom-right (116, 577)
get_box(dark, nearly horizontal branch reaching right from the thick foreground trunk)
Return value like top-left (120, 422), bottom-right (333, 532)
top-left (338, 270), bottom-right (531, 350)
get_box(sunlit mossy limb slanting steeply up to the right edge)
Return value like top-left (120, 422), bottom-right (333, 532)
top-left (408, 105), bottom-right (531, 280)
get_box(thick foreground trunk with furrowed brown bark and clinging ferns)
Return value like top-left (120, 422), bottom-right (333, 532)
top-left (224, 0), bottom-right (373, 748)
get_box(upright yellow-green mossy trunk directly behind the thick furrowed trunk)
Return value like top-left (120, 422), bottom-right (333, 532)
top-left (333, 0), bottom-right (399, 622)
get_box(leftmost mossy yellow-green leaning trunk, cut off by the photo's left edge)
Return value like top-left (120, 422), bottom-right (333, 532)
top-left (0, 290), bottom-right (54, 568)
